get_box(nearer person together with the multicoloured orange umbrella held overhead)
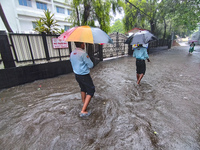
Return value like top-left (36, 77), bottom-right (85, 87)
top-left (58, 26), bottom-right (113, 117)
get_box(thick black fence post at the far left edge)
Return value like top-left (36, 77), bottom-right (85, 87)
top-left (0, 31), bottom-right (16, 68)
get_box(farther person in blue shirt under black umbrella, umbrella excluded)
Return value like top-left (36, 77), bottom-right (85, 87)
top-left (133, 44), bottom-right (150, 85)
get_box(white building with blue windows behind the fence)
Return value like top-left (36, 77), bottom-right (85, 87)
top-left (0, 0), bottom-right (72, 33)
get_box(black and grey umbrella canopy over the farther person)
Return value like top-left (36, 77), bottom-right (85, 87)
top-left (125, 30), bottom-right (157, 45)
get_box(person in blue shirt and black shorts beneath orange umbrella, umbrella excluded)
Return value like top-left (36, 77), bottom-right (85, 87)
top-left (70, 42), bottom-right (95, 117)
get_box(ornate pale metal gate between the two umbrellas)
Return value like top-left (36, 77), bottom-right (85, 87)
top-left (103, 32), bottom-right (128, 58)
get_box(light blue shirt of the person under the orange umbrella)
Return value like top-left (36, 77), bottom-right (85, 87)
top-left (70, 48), bottom-right (93, 75)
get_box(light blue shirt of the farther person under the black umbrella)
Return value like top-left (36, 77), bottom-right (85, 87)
top-left (133, 47), bottom-right (149, 60)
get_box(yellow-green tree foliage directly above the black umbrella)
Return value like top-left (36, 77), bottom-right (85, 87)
top-left (123, 0), bottom-right (158, 33)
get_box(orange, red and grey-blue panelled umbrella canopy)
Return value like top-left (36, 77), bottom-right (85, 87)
top-left (58, 26), bottom-right (113, 44)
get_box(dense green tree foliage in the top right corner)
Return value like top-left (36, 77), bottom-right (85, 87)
top-left (159, 0), bottom-right (200, 37)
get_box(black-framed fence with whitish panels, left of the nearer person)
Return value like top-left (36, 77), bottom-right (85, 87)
top-left (9, 33), bottom-right (70, 65)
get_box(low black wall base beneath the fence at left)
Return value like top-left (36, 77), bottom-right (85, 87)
top-left (0, 60), bottom-right (73, 89)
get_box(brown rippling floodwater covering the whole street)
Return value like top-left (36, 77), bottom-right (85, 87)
top-left (0, 46), bottom-right (200, 150)
